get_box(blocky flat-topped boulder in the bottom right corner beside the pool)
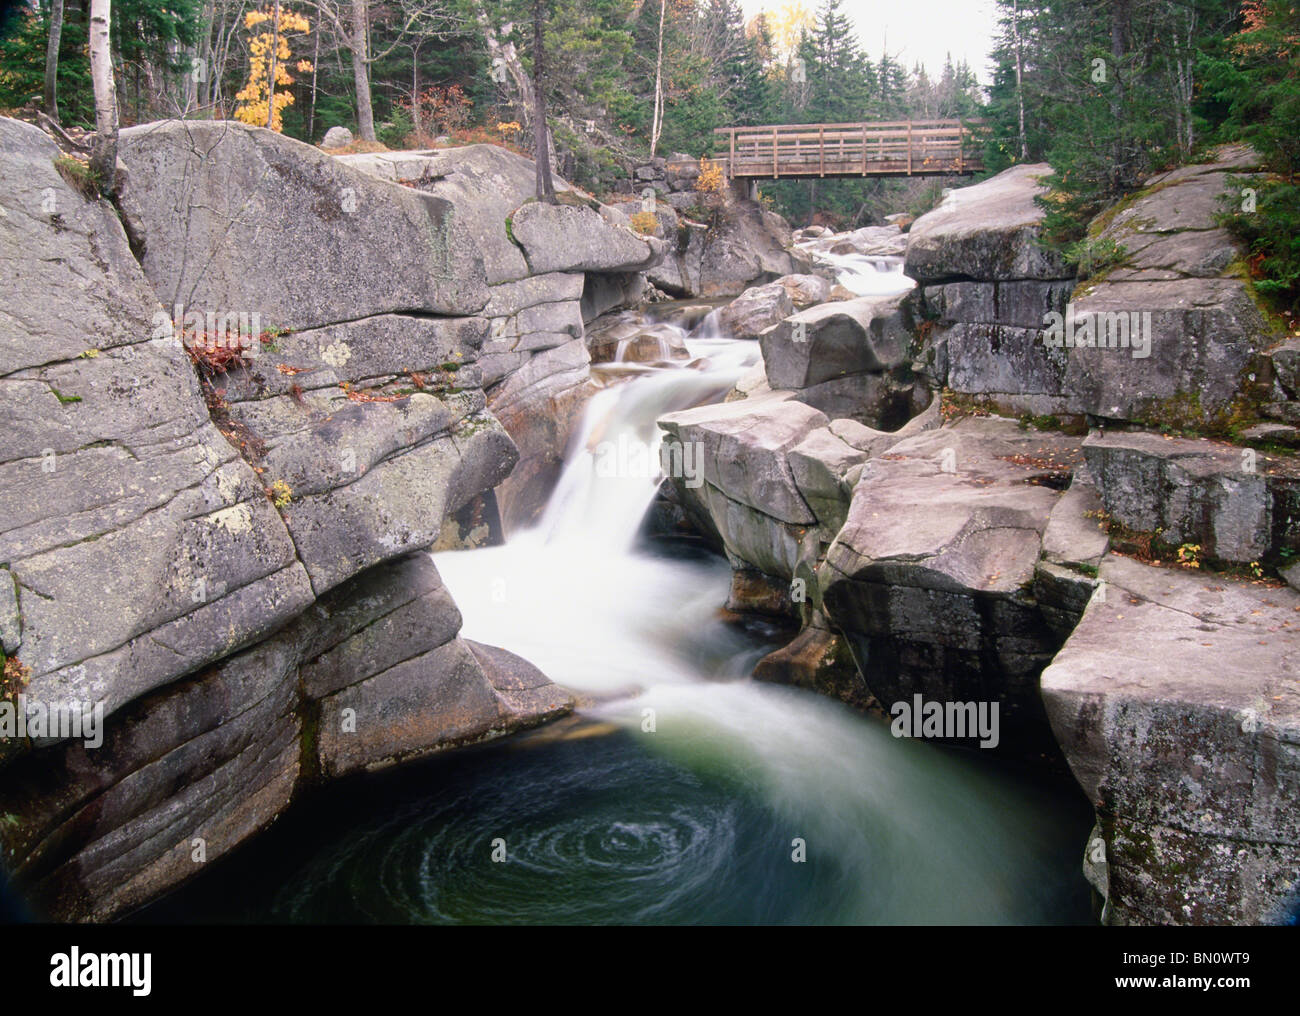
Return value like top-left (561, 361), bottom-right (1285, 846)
top-left (1043, 556), bottom-right (1300, 925)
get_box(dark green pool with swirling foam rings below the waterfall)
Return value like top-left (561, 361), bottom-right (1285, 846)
top-left (137, 707), bottom-right (1091, 924)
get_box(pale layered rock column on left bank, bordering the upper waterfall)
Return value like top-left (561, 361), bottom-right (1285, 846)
top-left (341, 144), bottom-right (660, 531)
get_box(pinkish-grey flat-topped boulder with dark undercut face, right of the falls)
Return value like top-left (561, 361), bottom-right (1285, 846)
top-left (819, 418), bottom-right (1079, 751)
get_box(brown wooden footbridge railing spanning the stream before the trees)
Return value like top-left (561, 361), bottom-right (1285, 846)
top-left (714, 120), bottom-right (983, 179)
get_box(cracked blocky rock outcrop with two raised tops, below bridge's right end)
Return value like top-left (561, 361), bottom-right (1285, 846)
top-left (907, 152), bottom-right (1268, 426)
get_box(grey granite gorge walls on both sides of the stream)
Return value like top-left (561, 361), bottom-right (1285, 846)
top-left (0, 120), bottom-right (1300, 924)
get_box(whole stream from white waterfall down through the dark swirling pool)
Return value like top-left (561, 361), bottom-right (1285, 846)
top-left (131, 320), bottom-right (1091, 924)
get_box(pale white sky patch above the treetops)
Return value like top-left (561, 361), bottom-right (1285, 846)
top-left (744, 0), bottom-right (997, 84)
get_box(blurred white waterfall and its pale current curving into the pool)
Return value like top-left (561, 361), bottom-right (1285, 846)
top-left (436, 315), bottom-right (1083, 922)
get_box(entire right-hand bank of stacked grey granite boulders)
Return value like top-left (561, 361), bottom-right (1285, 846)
top-left (663, 151), bottom-right (1300, 924)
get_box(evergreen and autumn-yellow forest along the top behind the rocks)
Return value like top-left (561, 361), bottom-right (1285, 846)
top-left (0, 0), bottom-right (1300, 308)
